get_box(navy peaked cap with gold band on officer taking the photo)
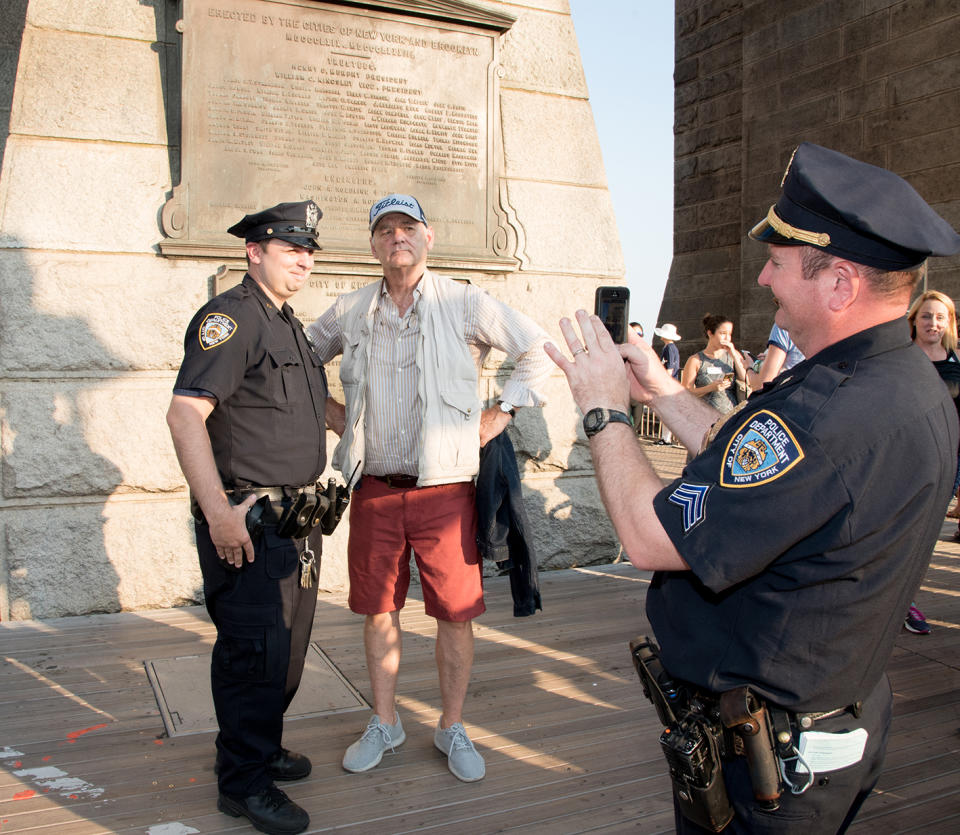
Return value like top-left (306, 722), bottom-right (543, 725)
top-left (749, 142), bottom-right (960, 271)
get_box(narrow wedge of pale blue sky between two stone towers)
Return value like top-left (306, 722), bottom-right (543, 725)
top-left (570, 0), bottom-right (674, 338)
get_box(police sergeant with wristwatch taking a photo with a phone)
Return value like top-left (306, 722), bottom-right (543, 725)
top-left (547, 143), bottom-right (960, 833)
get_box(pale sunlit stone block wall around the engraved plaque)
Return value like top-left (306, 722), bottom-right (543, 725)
top-left (0, 0), bottom-right (624, 620)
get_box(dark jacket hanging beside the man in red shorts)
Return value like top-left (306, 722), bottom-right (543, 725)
top-left (477, 432), bottom-right (543, 618)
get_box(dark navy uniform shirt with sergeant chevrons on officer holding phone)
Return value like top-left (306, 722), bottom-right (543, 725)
top-left (647, 319), bottom-right (958, 711)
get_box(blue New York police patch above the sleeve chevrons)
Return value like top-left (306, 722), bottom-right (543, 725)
top-left (720, 410), bottom-right (804, 487)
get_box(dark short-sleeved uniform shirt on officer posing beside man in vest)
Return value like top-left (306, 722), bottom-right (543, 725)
top-left (174, 275), bottom-right (327, 487)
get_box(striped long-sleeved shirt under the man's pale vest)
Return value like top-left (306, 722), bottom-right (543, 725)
top-left (307, 280), bottom-right (553, 475)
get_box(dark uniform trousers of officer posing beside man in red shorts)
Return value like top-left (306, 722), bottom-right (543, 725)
top-left (196, 522), bottom-right (321, 797)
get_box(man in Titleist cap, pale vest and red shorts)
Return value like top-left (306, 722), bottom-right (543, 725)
top-left (308, 194), bottom-right (552, 782)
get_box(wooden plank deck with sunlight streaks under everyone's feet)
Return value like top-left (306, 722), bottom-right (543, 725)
top-left (0, 474), bottom-right (960, 835)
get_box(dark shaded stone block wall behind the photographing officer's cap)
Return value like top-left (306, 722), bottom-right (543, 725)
top-left (660, 0), bottom-right (960, 358)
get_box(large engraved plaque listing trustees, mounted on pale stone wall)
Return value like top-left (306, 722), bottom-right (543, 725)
top-left (160, 0), bottom-right (523, 264)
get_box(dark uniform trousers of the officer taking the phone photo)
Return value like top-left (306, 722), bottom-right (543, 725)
top-left (674, 676), bottom-right (893, 835)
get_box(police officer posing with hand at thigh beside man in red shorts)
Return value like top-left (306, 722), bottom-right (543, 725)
top-left (167, 200), bottom-right (327, 833)
